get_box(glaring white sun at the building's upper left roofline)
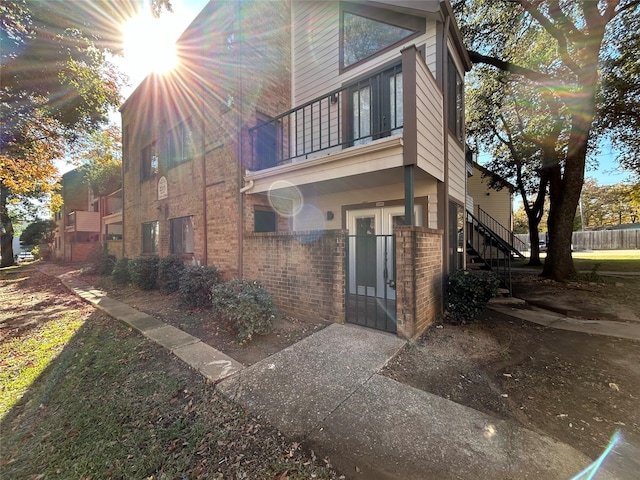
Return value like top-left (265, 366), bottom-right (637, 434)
top-left (122, 13), bottom-right (178, 75)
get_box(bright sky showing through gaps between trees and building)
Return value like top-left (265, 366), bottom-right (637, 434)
top-left (57, 0), bottom-right (629, 185)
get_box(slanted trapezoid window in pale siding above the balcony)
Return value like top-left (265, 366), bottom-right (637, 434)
top-left (340, 3), bottom-right (426, 68)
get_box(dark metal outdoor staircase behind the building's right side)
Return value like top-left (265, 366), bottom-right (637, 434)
top-left (466, 211), bottom-right (524, 295)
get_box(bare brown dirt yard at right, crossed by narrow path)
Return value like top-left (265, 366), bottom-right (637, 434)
top-left (384, 276), bottom-right (640, 458)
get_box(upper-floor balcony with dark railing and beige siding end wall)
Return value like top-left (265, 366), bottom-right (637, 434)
top-left (245, 47), bottom-right (445, 192)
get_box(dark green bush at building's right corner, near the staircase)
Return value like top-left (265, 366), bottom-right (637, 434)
top-left (447, 270), bottom-right (500, 323)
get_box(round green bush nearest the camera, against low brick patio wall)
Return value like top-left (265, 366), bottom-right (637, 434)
top-left (211, 280), bottom-right (278, 341)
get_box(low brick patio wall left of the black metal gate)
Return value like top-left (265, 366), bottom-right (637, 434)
top-left (243, 230), bottom-right (345, 323)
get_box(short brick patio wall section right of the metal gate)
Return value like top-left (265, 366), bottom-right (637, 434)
top-left (395, 226), bottom-right (443, 339)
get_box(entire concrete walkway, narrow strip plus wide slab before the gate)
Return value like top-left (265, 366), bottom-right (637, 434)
top-left (48, 268), bottom-right (636, 480)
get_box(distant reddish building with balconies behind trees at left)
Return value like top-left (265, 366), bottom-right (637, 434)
top-left (53, 169), bottom-right (122, 263)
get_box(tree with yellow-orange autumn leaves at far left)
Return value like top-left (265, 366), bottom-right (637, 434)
top-left (0, 0), bottom-right (171, 266)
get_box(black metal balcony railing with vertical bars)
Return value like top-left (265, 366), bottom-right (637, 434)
top-left (245, 64), bottom-right (404, 171)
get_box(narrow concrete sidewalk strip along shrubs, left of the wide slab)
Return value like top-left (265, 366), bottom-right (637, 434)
top-left (50, 270), bottom-right (244, 383)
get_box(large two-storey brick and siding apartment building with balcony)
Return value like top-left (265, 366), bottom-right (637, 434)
top-left (121, 0), bottom-right (471, 337)
